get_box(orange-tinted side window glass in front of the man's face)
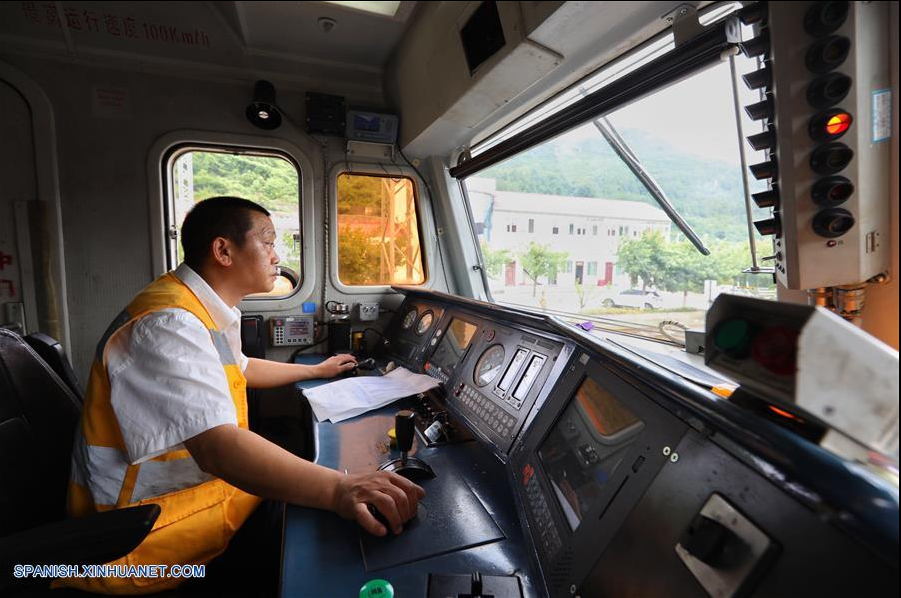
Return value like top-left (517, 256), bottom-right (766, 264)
top-left (337, 172), bottom-right (426, 286)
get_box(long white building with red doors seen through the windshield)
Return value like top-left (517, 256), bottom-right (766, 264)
top-left (466, 178), bottom-right (670, 288)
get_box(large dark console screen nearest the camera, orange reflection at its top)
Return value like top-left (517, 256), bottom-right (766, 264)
top-left (538, 378), bottom-right (644, 530)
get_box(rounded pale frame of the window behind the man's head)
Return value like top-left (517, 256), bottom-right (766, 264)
top-left (148, 130), bottom-right (318, 312)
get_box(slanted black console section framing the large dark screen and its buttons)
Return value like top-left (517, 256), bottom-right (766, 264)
top-left (510, 354), bottom-right (687, 596)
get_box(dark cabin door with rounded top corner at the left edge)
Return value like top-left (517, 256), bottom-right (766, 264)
top-left (0, 79), bottom-right (38, 335)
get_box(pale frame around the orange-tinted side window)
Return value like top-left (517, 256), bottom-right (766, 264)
top-left (328, 161), bottom-right (438, 295)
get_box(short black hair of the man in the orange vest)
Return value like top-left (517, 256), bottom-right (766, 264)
top-left (181, 197), bottom-right (269, 270)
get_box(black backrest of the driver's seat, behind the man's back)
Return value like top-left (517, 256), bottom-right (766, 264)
top-left (0, 328), bottom-right (81, 536)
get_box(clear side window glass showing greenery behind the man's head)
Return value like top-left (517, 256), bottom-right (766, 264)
top-left (167, 149), bottom-right (302, 298)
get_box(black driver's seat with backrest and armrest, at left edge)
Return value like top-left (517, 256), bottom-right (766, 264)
top-left (0, 328), bottom-right (160, 595)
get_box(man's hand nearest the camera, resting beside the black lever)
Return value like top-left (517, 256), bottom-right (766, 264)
top-left (333, 471), bottom-right (425, 536)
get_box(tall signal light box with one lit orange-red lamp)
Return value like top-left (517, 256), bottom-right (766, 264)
top-left (742, 2), bottom-right (891, 290)
